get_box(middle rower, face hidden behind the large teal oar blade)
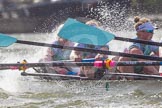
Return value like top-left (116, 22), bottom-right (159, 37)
top-left (70, 20), bottom-right (109, 79)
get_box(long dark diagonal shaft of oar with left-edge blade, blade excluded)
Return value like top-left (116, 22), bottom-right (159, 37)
top-left (16, 40), bottom-right (162, 61)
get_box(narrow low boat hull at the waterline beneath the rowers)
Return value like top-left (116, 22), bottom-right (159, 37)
top-left (21, 72), bottom-right (162, 80)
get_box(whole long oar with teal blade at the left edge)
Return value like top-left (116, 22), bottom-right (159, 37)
top-left (0, 34), bottom-right (162, 61)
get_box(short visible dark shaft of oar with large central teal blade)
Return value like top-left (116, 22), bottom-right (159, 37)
top-left (114, 36), bottom-right (162, 46)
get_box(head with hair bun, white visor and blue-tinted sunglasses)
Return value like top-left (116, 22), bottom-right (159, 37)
top-left (134, 16), bottom-right (155, 40)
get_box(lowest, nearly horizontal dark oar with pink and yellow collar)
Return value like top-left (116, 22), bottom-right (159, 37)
top-left (0, 61), bottom-right (162, 69)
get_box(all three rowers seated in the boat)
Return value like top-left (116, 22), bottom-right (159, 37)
top-left (38, 17), bottom-right (159, 78)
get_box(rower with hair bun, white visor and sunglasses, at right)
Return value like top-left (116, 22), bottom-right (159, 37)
top-left (117, 16), bottom-right (159, 74)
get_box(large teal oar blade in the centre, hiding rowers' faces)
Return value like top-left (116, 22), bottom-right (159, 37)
top-left (58, 18), bottom-right (115, 45)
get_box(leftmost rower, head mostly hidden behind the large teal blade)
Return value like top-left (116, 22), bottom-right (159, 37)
top-left (35, 25), bottom-right (77, 79)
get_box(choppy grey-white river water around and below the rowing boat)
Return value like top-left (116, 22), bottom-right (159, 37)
top-left (0, 30), bottom-right (162, 108)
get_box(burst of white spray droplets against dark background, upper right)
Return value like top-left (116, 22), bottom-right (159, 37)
top-left (88, 1), bottom-right (133, 32)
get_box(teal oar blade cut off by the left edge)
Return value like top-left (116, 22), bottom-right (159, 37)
top-left (0, 34), bottom-right (17, 47)
